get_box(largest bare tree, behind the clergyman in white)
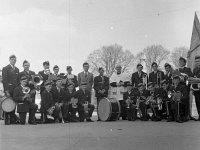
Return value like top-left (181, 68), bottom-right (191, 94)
top-left (87, 44), bottom-right (134, 77)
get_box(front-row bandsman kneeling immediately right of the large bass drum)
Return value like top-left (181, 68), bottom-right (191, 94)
top-left (122, 82), bottom-right (137, 121)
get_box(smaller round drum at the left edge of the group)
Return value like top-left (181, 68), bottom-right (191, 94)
top-left (1, 97), bottom-right (16, 112)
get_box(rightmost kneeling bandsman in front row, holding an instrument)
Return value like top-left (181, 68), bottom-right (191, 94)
top-left (169, 75), bottom-right (189, 123)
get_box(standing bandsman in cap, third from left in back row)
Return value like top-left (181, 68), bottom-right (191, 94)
top-left (38, 61), bottom-right (51, 93)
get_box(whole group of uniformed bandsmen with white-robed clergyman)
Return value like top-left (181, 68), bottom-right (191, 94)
top-left (0, 55), bottom-right (200, 125)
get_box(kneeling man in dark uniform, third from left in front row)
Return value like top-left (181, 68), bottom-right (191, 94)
top-left (51, 77), bottom-right (70, 122)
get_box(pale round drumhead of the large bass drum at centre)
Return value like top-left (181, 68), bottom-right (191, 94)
top-left (98, 98), bottom-right (111, 121)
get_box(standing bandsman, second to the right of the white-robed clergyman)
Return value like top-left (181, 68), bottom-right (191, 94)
top-left (149, 62), bottom-right (164, 88)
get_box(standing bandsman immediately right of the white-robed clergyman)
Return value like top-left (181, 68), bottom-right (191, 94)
top-left (131, 64), bottom-right (147, 87)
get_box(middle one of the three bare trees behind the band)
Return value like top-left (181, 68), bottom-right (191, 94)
top-left (143, 45), bottom-right (170, 72)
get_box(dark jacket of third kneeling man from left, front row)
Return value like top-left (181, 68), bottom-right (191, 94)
top-left (51, 87), bottom-right (70, 103)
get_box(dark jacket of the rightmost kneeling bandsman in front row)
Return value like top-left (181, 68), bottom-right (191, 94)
top-left (169, 83), bottom-right (189, 104)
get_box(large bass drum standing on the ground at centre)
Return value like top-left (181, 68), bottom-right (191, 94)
top-left (98, 98), bottom-right (121, 121)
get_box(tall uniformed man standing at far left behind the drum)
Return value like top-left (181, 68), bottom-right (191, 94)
top-left (2, 55), bottom-right (19, 125)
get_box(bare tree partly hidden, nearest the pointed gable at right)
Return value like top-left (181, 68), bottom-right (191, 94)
top-left (170, 46), bottom-right (189, 68)
